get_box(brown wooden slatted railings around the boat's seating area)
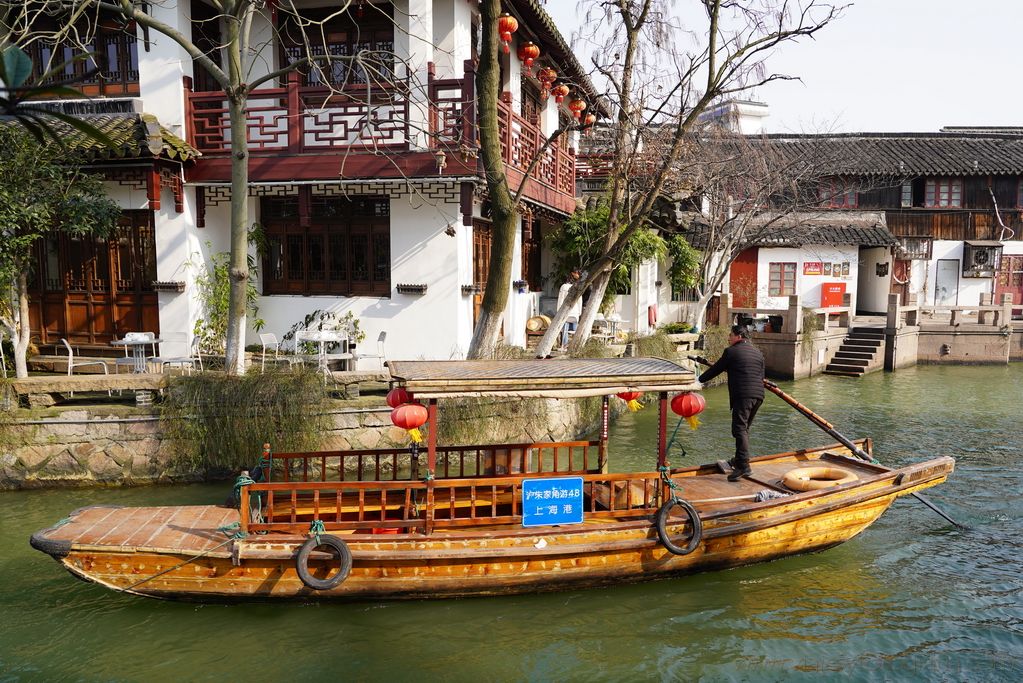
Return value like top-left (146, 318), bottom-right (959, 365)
top-left (241, 441), bottom-right (660, 534)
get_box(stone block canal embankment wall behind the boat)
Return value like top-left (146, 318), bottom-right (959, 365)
top-left (0, 400), bottom-right (597, 490)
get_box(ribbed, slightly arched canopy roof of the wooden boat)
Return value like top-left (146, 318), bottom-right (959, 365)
top-left (388, 358), bottom-right (701, 399)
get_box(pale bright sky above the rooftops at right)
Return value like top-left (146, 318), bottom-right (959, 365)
top-left (546, 0), bottom-right (1023, 133)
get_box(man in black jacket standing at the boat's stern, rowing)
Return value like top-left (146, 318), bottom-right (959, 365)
top-left (700, 325), bottom-right (764, 482)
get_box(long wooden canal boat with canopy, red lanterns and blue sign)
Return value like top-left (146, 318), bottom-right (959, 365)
top-left (31, 359), bottom-right (953, 600)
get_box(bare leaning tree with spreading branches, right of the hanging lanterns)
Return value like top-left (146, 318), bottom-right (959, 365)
top-left (531, 0), bottom-right (842, 356)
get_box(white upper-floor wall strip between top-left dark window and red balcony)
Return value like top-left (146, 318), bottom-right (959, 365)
top-left (137, 0), bottom-right (191, 137)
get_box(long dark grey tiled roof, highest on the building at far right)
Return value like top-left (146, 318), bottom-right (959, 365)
top-left (765, 132), bottom-right (1023, 176)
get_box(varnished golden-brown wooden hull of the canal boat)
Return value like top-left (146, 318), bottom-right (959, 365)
top-left (32, 458), bottom-right (952, 601)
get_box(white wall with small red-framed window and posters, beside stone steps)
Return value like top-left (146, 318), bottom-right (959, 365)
top-left (757, 244), bottom-right (859, 310)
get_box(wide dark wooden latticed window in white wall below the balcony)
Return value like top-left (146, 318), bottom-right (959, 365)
top-left (262, 193), bottom-right (391, 297)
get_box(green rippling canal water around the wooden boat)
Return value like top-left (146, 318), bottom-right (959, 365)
top-left (0, 365), bottom-right (1023, 683)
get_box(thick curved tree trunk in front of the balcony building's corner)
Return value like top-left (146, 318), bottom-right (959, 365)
top-left (466, 0), bottom-right (518, 358)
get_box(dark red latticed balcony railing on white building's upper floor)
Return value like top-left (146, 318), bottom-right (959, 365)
top-left (185, 62), bottom-right (575, 212)
